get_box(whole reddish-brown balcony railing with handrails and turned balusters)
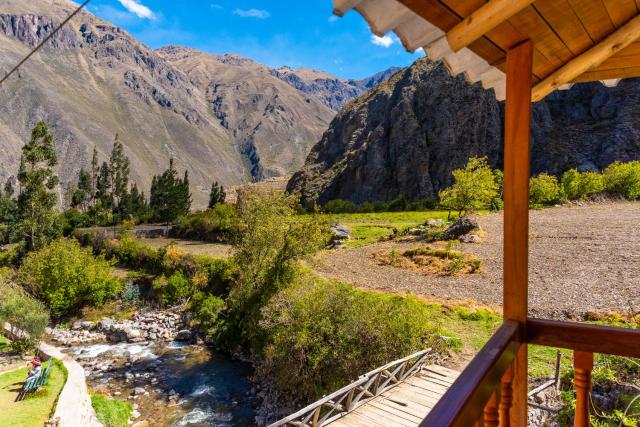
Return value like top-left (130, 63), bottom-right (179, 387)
top-left (421, 319), bottom-right (640, 427)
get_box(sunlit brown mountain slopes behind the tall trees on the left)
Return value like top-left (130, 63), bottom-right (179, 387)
top-left (0, 0), bottom-right (397, 206)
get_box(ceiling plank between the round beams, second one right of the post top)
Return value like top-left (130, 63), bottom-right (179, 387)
top-left (533, 0), bottom-right (592, 55)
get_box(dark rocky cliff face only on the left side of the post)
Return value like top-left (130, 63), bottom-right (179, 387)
top-left (288, 59), bottom-right (501, 203)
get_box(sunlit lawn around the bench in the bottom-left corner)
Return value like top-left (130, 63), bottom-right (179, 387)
top-left (0, 361), bottom-right (67, 427)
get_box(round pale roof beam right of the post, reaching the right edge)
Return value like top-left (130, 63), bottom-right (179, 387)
top-left (531, 15), bottom-right (640, 102)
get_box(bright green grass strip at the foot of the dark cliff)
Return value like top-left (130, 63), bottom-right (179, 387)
top-left (326, 211), bottom-right (448, 248)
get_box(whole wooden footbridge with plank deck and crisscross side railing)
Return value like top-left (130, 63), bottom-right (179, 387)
top-left (269, 350), bottom-right (458, 427)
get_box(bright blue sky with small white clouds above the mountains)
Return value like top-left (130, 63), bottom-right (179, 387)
top-left (89, 0), bottom-right (420, 78)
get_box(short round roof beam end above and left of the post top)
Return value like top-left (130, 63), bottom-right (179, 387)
top-left (447, 0), bottom-right (534, 52)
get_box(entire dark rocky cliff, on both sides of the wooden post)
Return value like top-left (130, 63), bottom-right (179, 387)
top-left (288, 59), bottom-right (640, 203)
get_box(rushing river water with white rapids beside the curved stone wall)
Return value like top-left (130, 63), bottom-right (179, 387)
top-left (69, 343), bottom-right (256, 427)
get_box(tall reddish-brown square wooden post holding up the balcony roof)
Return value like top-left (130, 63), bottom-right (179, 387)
top-left (503, 40), bottom-right (533, 427)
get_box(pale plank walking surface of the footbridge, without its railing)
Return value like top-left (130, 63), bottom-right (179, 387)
top-left (330, 365), bottom-right (459, 427)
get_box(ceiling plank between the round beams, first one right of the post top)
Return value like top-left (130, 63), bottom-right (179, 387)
top-left (509, 7), bottom-right (574, 67)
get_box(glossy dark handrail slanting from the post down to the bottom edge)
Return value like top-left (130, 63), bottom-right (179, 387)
top-left (420, 320), bottom-right (522, 427)
